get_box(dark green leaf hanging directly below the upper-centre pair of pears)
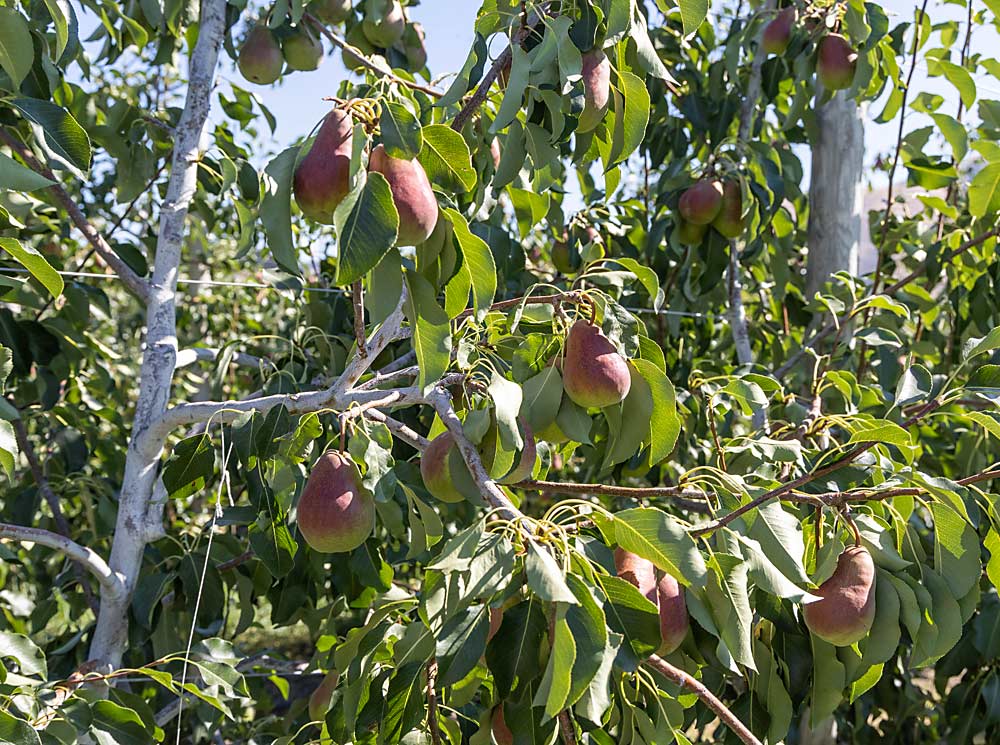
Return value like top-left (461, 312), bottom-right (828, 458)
top-left (333, 171), bottom-right (399, 285)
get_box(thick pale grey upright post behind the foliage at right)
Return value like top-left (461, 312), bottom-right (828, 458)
top-left (806, 91), bottom-right (865, 298)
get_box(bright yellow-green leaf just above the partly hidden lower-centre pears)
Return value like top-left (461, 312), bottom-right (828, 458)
top-left (614, 507), bottom-right (706, 586)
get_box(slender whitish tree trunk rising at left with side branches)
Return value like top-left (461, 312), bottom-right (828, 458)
top-left (90, 0), bottom-right (226, 669)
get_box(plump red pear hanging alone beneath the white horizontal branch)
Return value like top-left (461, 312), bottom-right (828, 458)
top-left (297, 450), bottom-right (375, 553)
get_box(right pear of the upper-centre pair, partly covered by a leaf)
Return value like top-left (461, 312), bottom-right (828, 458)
top-left (368, 145), bottom-right (438, 246)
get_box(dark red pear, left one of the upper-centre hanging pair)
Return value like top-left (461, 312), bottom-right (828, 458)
top-left (292, 109), bottom-right (354, 225)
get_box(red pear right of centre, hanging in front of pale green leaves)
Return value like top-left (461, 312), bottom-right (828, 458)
top-left (563, 319), bottom-right (632, 409)
